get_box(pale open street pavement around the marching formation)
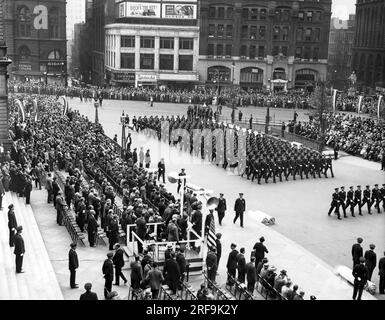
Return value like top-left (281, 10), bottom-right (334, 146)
top-left (69, 99), bottom-right (385, 298)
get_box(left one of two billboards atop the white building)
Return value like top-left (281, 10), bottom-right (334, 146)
top-left (119, 2), bottom-right (160, 18)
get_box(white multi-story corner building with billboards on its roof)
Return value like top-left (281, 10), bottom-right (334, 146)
top-left (105, 0), bottom-right (199, 88)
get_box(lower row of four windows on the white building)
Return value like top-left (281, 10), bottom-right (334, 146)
top-left (120, 53), bottom-right (193, 71)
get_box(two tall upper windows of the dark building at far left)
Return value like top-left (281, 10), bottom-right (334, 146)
top-left (16, 6), bottom-right (61, 39)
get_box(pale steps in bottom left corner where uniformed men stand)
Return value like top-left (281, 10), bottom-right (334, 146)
top-left (0, 192), bottom-right (63, 300)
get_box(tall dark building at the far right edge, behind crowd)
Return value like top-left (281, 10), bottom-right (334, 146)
top-left (352, 0), bottom-right (385, 88)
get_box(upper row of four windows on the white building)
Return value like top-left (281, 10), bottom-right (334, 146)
top-left (120, 36), bottom-right (194, 50)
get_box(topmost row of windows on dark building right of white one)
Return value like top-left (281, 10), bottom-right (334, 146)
top-left (209, 6), bottom-right (322, 22)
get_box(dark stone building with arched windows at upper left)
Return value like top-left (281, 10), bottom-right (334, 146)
top-left (4, 0), bottom-right (67, 84)
